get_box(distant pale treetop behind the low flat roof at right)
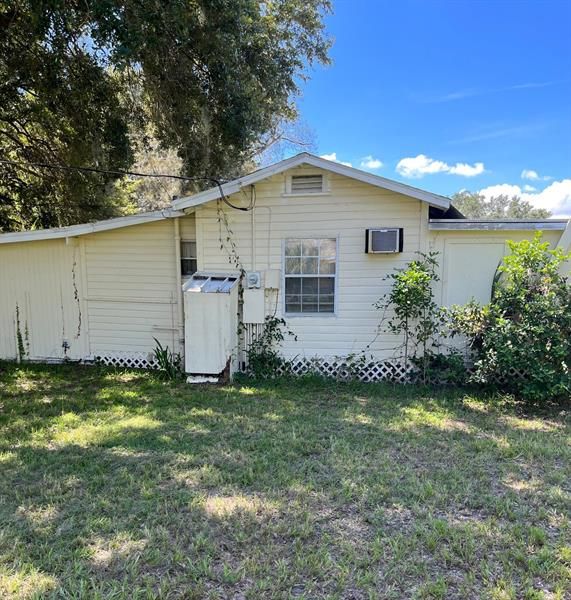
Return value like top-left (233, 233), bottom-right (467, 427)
top-left (452, 191), bottom-right (551, 219)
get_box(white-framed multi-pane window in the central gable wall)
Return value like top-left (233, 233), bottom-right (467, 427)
top-left (285, 238), bottom-right (337, 314)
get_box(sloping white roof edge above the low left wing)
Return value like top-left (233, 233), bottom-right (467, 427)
top-left (0, 208), bottom-right (184, 244)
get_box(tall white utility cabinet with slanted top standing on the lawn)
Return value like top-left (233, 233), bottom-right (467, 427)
top-left (182, 273), bottom-right (238, 375)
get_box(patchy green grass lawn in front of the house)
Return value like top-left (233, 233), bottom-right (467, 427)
top-left (0, 364), bottom-right (571, 599)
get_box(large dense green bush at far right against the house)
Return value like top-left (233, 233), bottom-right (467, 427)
top-left (448, 234), bottom-right (571, 402)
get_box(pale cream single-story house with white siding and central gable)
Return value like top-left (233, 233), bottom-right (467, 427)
top-left (0, 153), bottom-right (571, 380)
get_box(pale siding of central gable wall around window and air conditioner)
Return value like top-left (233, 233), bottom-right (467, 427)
top-left (196, 168), bottom-right (428, 358)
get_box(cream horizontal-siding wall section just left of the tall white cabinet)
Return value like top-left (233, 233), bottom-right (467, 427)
top-left (81, 219), bottom-right (181, 356)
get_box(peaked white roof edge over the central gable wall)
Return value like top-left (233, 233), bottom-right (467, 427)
top-left (172, 152), bottom-right (450, 210)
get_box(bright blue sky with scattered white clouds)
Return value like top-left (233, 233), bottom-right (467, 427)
top-left (299, 0), bottom-right (571, 214)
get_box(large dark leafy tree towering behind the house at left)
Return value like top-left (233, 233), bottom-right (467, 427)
top-left (0, 0), bottom-right (331, 230)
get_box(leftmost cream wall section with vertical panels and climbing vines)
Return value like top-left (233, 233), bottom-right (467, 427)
top-left (0, 239), bottom-right (87, 360)
